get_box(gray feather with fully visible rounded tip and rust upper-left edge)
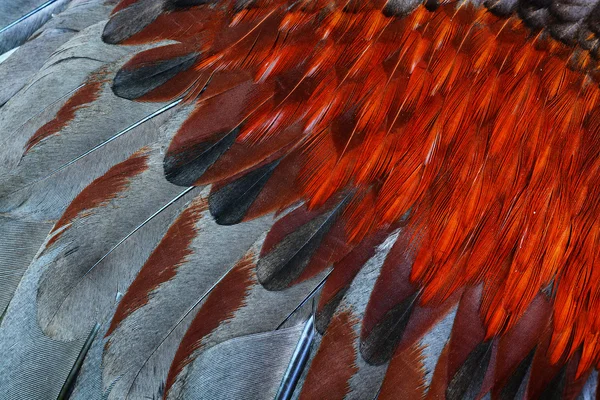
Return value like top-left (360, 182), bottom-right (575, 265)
top-left (38, 150), bottom-right (202, 338)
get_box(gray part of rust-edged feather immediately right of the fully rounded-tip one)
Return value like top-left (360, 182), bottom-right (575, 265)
top-left (103, 198), bottom-right (271, 399)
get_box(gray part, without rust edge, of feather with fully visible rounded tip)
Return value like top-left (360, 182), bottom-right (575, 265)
top-left (36, 145), bottom-right (192, 338)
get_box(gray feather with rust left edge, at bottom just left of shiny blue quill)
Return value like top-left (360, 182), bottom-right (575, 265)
top-left (166, 240), bottom-right (326, 398)
